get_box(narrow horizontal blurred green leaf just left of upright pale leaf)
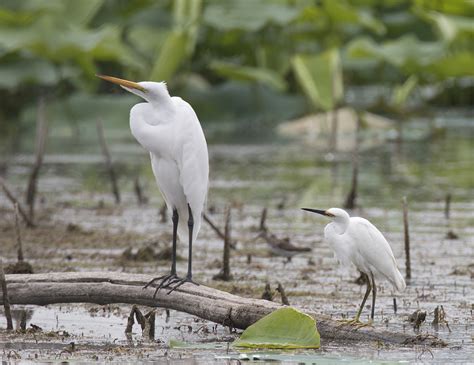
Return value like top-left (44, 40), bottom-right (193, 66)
top-left (210, 61), bottom-right (286, 91)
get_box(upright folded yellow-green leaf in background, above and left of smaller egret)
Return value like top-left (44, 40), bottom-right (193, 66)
top-left (291, 49), bottom-right (344, 111)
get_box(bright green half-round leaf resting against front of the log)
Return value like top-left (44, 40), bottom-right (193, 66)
top-left (233, 307), bottom-right (320, 349)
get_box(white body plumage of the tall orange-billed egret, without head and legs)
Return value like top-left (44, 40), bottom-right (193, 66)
top-left (130, 97), bottom-right (209, 242)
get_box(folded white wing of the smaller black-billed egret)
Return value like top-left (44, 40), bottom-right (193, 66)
top-left (350, 218), bottom-right (404, 288)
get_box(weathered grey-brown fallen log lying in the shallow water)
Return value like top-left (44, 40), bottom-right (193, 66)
top-left (0, 272), bottom-right (446, 346)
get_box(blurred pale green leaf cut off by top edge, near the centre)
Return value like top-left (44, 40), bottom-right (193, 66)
top-left (203, 0), bottom-right (299, 32)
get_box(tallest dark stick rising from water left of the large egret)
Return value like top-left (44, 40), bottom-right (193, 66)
top-left (26, 96), bottom-right (48, 220)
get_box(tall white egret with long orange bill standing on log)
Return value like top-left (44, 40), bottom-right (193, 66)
top-left (97, 75), bottom-right (209, 296)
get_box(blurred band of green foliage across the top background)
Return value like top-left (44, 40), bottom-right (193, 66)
top-left (0, 0), bottom-right (474, 131)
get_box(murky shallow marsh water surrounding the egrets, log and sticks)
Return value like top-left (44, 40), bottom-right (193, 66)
top-left (0, 107), bottom-right (474, 364)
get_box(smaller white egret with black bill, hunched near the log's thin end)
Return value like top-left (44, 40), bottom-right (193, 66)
top-left (302, 208), bottom-right (406, 323)
